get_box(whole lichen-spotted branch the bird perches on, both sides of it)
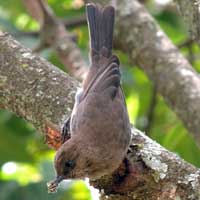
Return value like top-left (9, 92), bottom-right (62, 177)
top-left (0, 32), bottom-right (200, 200)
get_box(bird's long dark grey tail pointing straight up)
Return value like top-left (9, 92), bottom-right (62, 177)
top-left (87, 3), bottom-right (114, 62)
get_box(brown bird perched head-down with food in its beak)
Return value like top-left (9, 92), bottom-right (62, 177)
top-left (48, 4), bottom-right (131, 192)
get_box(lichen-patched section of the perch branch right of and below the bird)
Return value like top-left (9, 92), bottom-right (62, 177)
top-left (94, 129), bottom-right (200, 200)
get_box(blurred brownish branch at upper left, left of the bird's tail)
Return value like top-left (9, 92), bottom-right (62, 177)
top-left (24, 0), bottom-right (87, 79)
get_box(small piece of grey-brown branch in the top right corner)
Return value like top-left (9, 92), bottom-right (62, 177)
top-left (175, 0), bottom-right (200, 41)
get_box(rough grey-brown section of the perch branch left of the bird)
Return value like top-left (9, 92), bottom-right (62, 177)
top-left (0, 32), bottom-right (78, 132)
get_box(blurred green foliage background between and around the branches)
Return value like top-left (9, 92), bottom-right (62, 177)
top-left (0, 0), bottom-right (200, 200)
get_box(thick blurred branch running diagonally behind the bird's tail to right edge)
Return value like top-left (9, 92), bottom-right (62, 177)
top-left (89, 0), bottom-right (200, 142)
